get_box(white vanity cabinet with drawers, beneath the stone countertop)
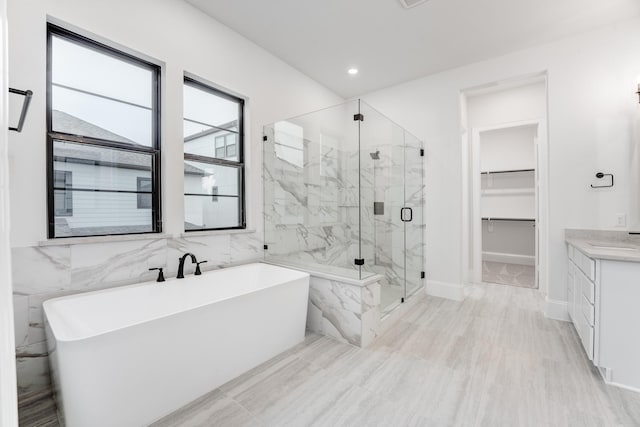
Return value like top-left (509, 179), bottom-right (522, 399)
top-left (567, 244), bottom-right (640, 391)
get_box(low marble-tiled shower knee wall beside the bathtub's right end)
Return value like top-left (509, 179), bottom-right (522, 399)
top-left (307, 276), bottom-right (380, 347)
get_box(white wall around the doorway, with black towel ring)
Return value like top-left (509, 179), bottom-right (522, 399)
top-left (363, 19), bottom-right (640, 300)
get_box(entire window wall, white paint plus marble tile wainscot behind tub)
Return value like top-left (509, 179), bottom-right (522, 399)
top-left (7, 0), bottom-right (343, 391)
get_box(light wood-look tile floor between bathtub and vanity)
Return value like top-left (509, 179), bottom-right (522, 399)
top-left (154, 285), bottom-right (640, 427)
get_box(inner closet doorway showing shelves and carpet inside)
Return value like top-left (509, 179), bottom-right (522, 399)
top-left (472, 122), bottom-right (539, 288)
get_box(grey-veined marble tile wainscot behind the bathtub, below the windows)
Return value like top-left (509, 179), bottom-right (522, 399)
top-left (12, 233), bottom-right (263, 392)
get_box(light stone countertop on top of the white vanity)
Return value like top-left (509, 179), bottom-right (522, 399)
top-left (565, 229), bottom-right (640, 262)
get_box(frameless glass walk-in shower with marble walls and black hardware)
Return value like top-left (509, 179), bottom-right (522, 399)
top-left (263, 100), bottom-right (425, 313)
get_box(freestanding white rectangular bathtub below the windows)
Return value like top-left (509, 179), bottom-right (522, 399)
top-left (44, 264), bottom-right (309, 427)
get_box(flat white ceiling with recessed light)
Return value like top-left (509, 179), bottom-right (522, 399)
top-left (186, 0), bottom-right (640, 98)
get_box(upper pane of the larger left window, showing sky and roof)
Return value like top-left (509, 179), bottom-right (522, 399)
top-left (50, 35), bottom-right (153, 147)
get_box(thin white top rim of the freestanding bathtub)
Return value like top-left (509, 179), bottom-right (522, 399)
top-left (42, 262), bottom-right (310, 344)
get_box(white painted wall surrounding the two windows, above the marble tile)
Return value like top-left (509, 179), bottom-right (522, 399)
top-left (9, 0), bottom-right (342, 246)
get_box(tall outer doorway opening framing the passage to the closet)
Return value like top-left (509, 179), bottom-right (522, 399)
top-left (463, 76), bottom-right (546, 288)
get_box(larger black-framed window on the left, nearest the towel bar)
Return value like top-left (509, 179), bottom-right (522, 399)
top-left (47, 24), bottom-right (161, 238)
